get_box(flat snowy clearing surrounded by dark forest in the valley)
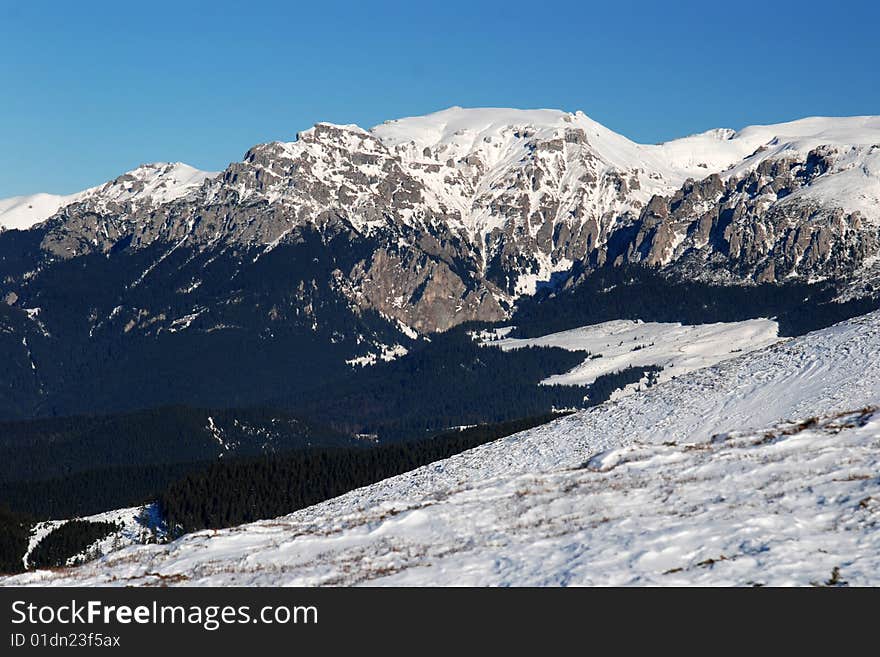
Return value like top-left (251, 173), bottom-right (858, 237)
top-left (482, 319), bottom-right (779, 394)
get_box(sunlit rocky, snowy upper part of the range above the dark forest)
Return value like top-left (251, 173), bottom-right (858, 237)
top-left (0, 108), bottom-right (880, 333)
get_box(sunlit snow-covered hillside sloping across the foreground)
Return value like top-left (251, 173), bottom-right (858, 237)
top-left (4, 313), bottom-right (880, 585)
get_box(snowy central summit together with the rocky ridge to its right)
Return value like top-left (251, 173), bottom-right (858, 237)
top-left (372, 108), bottom-right (880, 295)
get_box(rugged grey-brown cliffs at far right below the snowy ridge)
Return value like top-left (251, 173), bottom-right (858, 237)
top-left (618, 147), bottom-right (880, 282)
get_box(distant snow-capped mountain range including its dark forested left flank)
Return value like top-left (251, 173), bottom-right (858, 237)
top-left (0, 107), bottom-right (880, 418)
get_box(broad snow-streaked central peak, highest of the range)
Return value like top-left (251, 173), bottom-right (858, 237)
top-left (371, 107), bottom-right (684, 258)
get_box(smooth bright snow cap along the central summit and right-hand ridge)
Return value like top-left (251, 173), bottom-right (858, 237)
top-left (371, 107), bottom-right (880, 222)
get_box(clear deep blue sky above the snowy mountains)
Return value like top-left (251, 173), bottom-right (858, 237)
top-left (0, 0), bottom-right (880, 197)
